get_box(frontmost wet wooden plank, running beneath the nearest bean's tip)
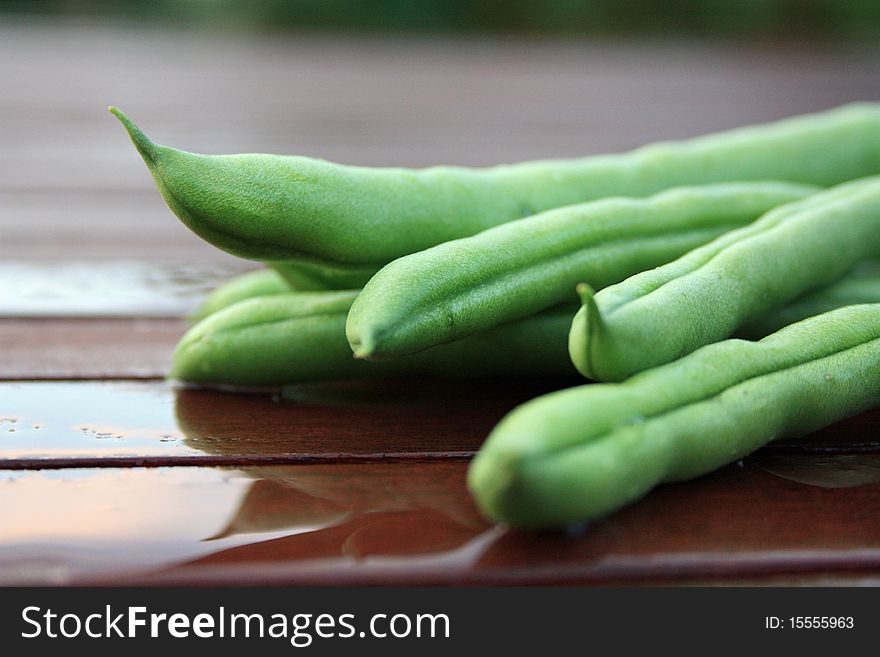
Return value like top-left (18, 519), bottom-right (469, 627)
top-left (0, 460), bottom-right (880, 584)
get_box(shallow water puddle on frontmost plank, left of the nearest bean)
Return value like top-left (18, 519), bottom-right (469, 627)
top-left (0, 464), bottom-right (487, 584)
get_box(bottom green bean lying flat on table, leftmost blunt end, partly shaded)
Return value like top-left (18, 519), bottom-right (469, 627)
top-left (170, 290), bottom-right (577, 387)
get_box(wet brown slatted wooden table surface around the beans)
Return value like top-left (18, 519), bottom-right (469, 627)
top-left (0, 23), bottom-right (880, 585)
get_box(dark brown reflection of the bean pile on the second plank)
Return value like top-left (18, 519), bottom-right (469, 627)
top-left (176, 380), bottom-right (577, 454)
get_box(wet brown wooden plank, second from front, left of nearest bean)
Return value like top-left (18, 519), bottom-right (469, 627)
top-left (0, 380), bottom-right (566, 468)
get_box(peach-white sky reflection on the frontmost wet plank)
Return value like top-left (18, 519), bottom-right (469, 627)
top-left (0, 468), bottom-right (328, 582)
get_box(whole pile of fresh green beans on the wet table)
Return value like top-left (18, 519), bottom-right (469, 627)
top-left (111, 103), bottom-right (880, 528)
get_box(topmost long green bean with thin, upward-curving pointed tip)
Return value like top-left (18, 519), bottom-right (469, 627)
top-left (110, 104), bottom-right (880, 268)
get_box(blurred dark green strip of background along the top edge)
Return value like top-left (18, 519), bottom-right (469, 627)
top-left (0, 0), bottom-right (880, 41)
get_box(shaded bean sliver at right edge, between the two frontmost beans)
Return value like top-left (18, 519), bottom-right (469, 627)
top-left (736, 260), bottom-right (880, 340)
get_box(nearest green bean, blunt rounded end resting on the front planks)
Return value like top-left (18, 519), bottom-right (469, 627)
top-left (468, 304), bottom-right (880, 528)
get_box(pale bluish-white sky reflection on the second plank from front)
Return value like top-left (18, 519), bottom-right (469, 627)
top-left (0, 382), bottom-right (198, 457)
